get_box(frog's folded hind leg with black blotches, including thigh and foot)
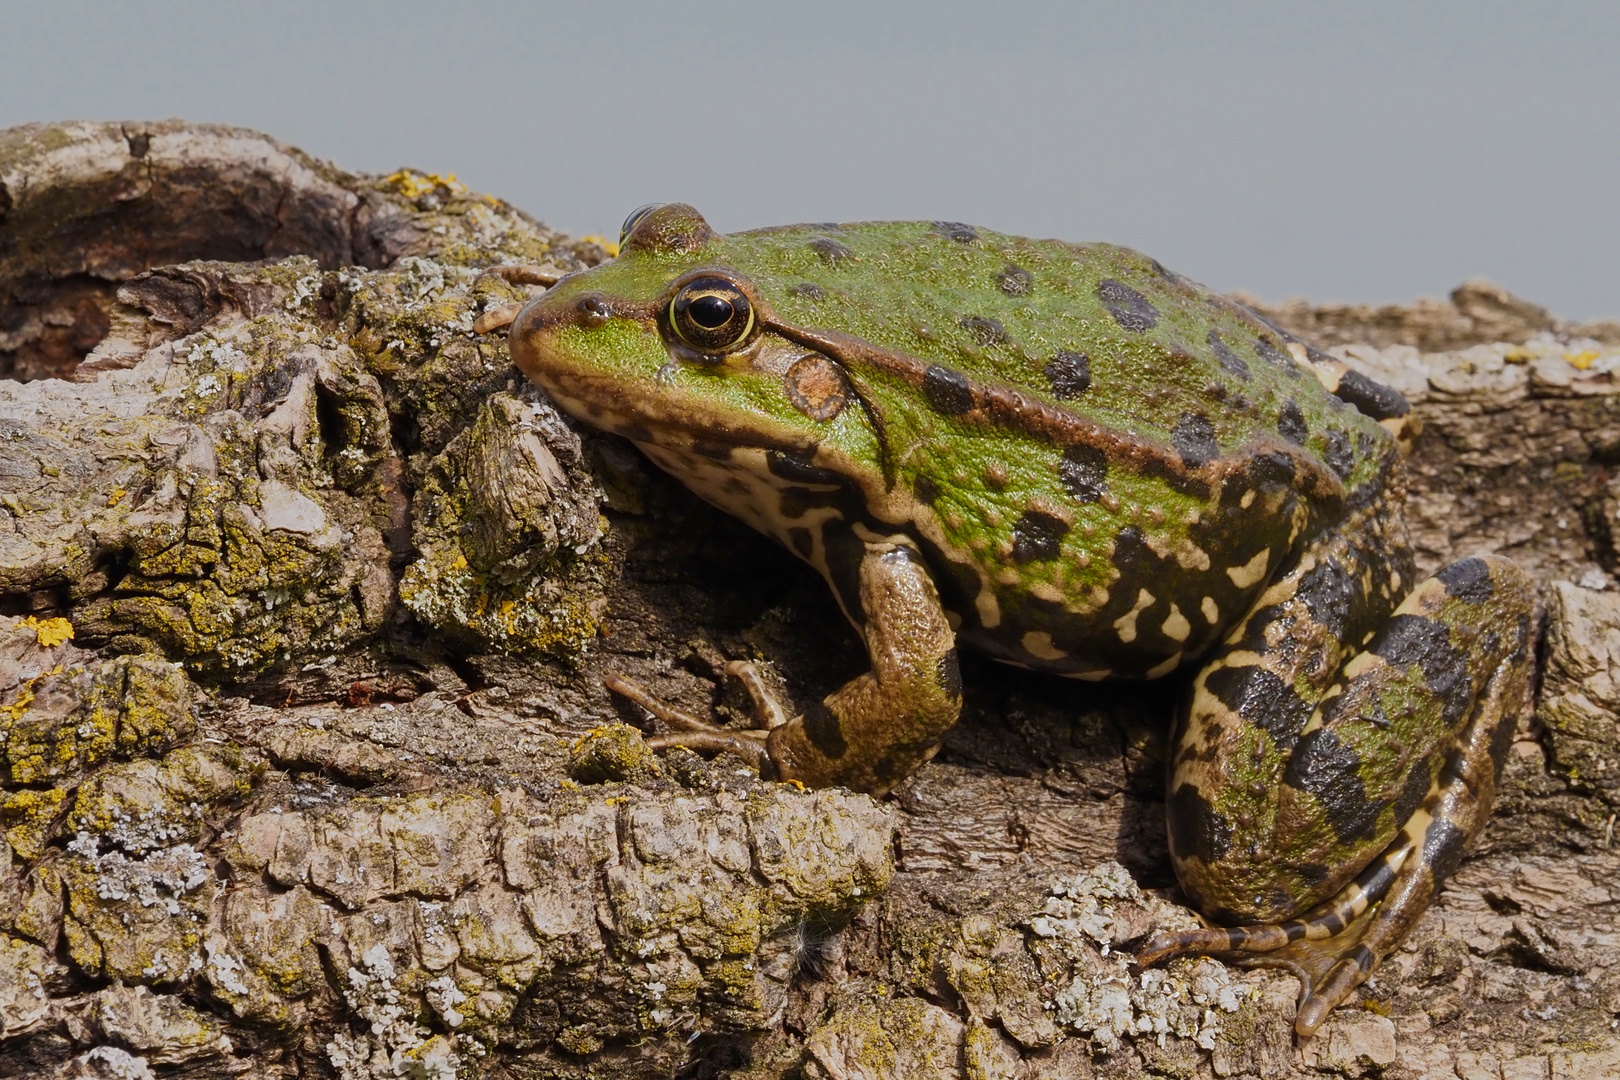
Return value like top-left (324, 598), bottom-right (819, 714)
top-left (1139, 549), bottom-right (1533, 1036)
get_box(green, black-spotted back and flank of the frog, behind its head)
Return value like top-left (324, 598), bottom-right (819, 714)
top-left (716, 222), bottom-right (1398, 678)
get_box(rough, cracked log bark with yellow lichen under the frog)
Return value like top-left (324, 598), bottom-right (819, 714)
top-left (0, 123), bottom-right (1620, 1080)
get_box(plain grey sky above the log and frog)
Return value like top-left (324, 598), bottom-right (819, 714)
top-left (0, 0), bottom-right (1620, 319)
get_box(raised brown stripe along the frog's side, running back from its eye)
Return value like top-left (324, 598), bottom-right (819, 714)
top-left (760, 320), bottom-right (1345, 502)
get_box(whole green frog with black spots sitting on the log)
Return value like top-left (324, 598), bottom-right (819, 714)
top-left (505, 202), bottom-right (1534, 1038)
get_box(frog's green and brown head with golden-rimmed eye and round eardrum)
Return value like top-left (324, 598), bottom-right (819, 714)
top-left (509, 202), bottom-right (851, 450)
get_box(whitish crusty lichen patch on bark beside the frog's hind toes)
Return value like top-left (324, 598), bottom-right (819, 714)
top-left (1029, 861), bottom-right (1254, 1052)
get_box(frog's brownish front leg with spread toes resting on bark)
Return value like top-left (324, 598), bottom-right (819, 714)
top-left (609, 536), bottom-right (962, 795)
